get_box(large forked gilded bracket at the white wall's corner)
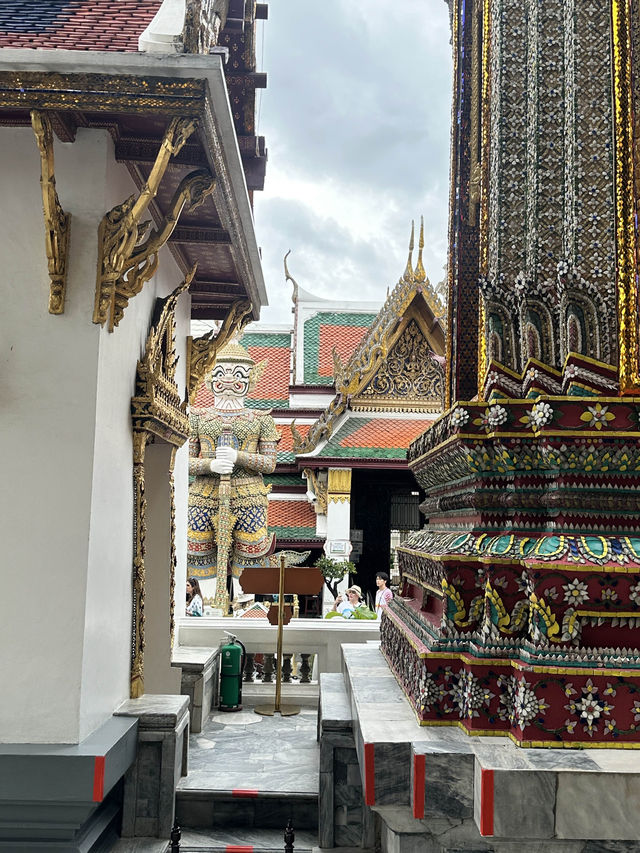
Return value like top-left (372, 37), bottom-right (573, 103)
top-left (93, 118), bottom-right (205, 332)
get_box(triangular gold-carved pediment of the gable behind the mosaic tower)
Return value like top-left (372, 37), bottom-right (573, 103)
top-left (351, 317), bottom-right (444, 411)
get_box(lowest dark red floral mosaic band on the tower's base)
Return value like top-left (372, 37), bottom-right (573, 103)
top-left (381, 600), bottom-right (640, 746)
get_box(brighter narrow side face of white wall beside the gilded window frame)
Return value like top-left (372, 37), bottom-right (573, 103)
top-left (80, 148), bottom-right (190, 737)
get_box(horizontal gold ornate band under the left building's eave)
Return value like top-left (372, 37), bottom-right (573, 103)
top-left (0, 71), bottom-right (207, 118)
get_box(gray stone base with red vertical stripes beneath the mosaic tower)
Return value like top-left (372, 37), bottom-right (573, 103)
top-left (320, 644), bottom-right (640, 853)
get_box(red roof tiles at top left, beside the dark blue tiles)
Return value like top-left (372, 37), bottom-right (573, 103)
top-left (0, 0), bottom-right (162, 52)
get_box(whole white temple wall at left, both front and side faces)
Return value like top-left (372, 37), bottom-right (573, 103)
top-left (0, 123), bottom-right (189, 743)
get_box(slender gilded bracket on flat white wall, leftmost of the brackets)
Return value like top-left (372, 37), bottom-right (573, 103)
top-left (31, 110), bottom-right (71, 314)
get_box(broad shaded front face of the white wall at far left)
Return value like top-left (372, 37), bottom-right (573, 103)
top-left (0, 128), bottom-right (98, 742)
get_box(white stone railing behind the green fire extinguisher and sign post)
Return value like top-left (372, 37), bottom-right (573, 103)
top-left (177, 616), bottom-right (380, 683)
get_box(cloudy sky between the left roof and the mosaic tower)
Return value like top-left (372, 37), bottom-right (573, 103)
top-left (255, 0), bottom-right (451, 323)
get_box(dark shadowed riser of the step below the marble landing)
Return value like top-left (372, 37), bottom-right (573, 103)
top-left (176, 788), bottom-right (318, 828)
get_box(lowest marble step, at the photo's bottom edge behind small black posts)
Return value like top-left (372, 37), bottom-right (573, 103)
top-left (175, 826), bottom-right (318, 853)
